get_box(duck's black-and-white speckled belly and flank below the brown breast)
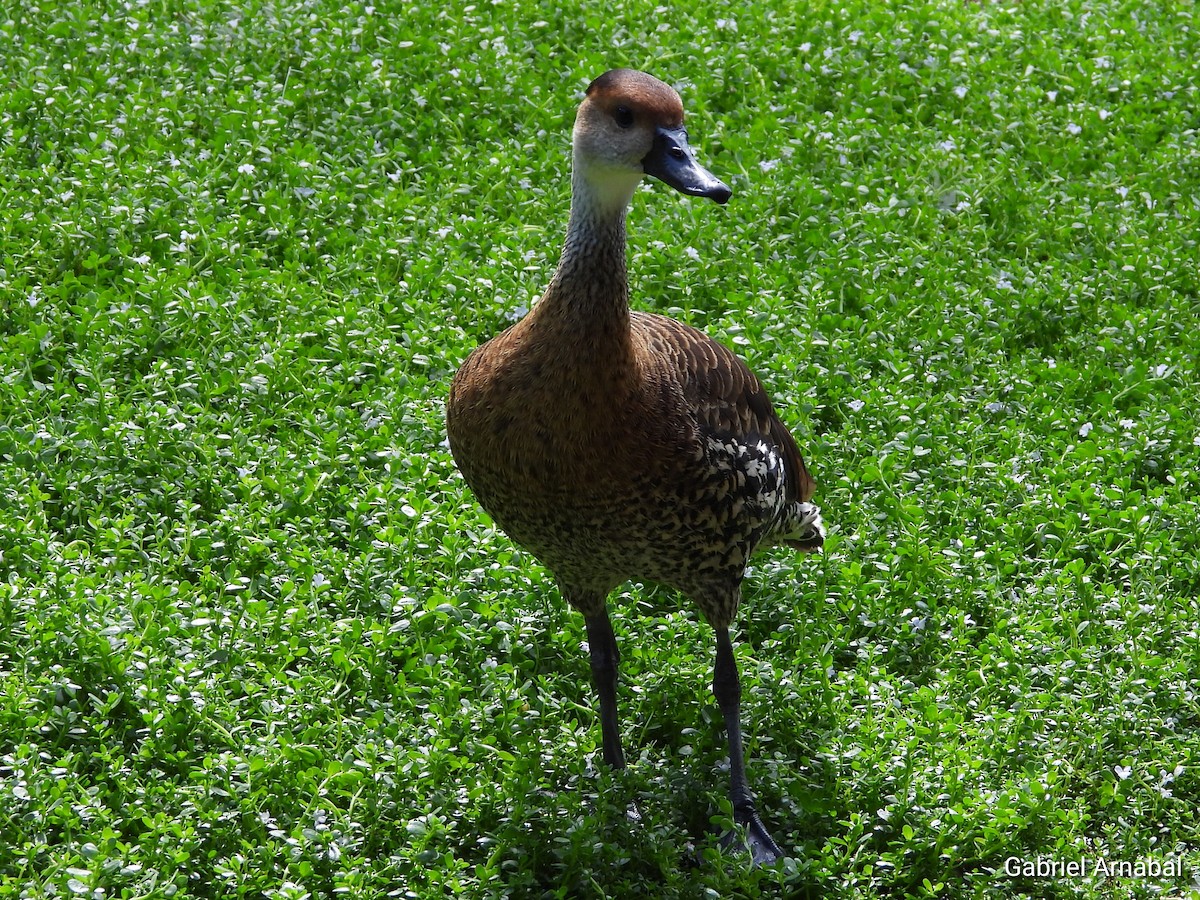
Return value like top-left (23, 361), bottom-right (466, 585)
top-left (468, 433), bottom-right (787, 607)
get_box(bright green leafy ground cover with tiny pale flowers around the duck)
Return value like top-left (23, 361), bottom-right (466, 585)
top-left (0, 0), bottom-right (1200, 900)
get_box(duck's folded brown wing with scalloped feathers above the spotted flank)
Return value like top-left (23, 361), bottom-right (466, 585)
top-left (630, 312), bottom-right (815, 502)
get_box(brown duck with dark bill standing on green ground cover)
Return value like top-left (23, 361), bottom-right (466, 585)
top-left (446, 68), bottom-right (824, 864)
